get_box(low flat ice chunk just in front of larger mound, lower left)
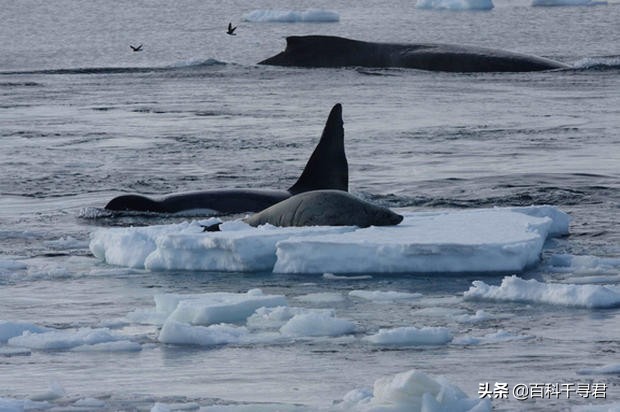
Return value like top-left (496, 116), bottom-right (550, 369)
top-left (159, 319), bottom-right (249, 346)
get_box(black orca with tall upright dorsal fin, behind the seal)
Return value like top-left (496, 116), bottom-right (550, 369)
top-left (105, 103), bottom-right (349, 214)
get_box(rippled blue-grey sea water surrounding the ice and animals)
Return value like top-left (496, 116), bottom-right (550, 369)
top-left (0, 0), bottom-right (620, 410)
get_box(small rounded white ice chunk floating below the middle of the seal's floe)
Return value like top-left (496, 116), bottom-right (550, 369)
top-left (280, 311), bottom-right (355, 337)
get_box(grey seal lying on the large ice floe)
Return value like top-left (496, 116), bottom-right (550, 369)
top-left (244, 190), bottom-right (403, 227)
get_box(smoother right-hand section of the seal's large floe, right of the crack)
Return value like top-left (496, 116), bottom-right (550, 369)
top-left (274, 206), bottom-right (568, 273)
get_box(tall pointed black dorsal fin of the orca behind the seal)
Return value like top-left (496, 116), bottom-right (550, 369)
top-left (288, 103), bottom-right (349, 195)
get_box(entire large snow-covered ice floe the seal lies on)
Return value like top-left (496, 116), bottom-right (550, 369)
top-left (90, 206), bottom-right (569, 274)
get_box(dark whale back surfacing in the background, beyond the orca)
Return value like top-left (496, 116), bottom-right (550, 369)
top-left (259, 36), bottom-right (569, 72)
